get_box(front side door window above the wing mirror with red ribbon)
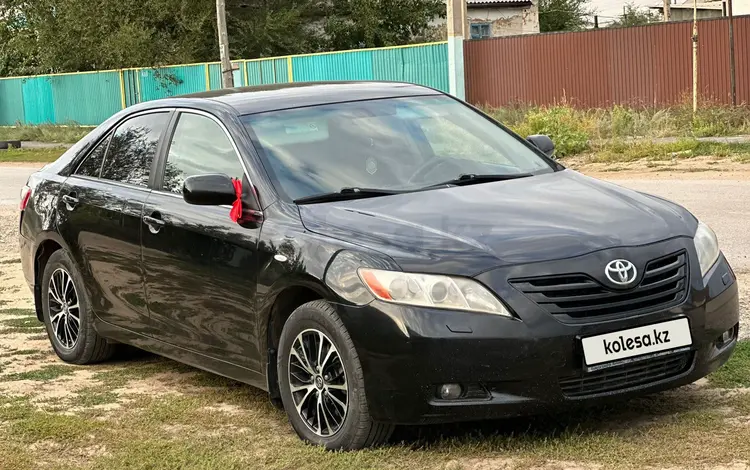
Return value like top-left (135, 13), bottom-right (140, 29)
top-left (163, 113), bottom-right (244, 194)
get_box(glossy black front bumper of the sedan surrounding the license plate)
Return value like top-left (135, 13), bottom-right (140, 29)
top-left (337, 256), bottom-right (739, 424)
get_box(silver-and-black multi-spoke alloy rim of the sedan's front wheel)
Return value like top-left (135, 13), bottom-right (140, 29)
top-left (288, 329), bottom-right (349, 437)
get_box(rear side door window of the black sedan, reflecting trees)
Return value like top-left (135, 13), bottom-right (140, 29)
top-left (101, 112), bottom-right (169, 186)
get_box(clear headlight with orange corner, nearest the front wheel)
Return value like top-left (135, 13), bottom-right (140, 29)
top-left (358, 268), bottom-right (511, 317)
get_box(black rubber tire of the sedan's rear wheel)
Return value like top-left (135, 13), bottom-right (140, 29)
top-left (41, 250), bottom-right (116, 364)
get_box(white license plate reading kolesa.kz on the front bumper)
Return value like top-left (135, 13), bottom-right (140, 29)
top-left (581, 318), bottom-right (693, 371)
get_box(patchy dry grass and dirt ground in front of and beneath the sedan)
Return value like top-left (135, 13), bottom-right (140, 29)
top-left (0, 296), bottom-right (750, 470)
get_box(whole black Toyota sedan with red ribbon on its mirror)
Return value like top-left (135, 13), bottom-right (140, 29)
top-left (20, 82), bottom-right (739, 449)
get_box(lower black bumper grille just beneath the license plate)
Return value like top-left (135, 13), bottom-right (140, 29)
top-left (560, 351), bottom-right (692, 398)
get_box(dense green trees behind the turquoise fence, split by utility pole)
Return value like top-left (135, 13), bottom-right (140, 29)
top-left (0, 0), bottom-right (445, 76)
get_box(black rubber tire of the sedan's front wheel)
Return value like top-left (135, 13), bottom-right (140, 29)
top-left (277, 300), bottom-right (394, 450)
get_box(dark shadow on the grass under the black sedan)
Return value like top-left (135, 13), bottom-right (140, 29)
top-left (97, 347), bottom-right (722, 450)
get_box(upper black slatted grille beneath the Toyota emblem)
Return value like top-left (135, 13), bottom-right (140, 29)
top-left (511, 250), bottom-right (688, 318)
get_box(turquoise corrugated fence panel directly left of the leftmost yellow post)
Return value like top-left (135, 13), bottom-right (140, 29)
top-left (47, 72), bottom-right (122, 125)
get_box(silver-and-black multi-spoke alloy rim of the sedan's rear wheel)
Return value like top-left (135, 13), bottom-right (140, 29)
top-left (47, 268), bottom-right (81, 350)
